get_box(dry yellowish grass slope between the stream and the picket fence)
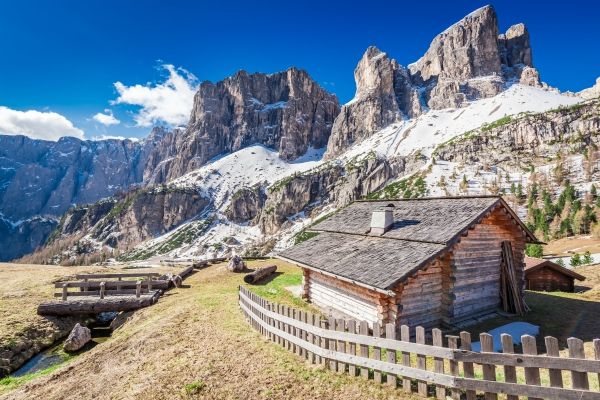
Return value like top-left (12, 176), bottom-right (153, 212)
top-left (0, 263), bottom-right (408, 400)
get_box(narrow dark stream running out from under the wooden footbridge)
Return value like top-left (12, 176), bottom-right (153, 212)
top-left (9, 312), bottom-right (117, 377)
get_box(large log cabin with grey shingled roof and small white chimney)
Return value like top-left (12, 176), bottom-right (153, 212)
top-left (278, 196), bottom-right (537, 327)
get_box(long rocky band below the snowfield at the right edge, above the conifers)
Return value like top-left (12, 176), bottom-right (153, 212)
top-left (435, 100), bottom-right (600, 166)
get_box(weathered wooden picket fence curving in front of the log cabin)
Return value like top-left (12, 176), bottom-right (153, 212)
top-left (239, 287), bottom-right (600, 400)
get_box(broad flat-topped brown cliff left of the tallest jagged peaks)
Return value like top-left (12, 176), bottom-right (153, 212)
top-left (154, 68), bottom-right (339, 181)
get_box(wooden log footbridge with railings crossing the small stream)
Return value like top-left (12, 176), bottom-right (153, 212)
top-left (37, 266), bottom-right (194, 315)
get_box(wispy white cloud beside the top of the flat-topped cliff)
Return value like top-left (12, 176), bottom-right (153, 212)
top-left (112, 64), bottom-right (197, 127)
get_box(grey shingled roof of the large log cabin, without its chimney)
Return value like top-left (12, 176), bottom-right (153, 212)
top-left (279, 196), bottom-right (536, 291)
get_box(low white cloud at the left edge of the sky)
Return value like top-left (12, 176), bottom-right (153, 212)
top-left (0, 106), bottom-right (83, 140)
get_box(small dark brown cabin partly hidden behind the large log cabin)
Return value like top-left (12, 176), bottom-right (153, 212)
top-left (525, 257), bottom-right (585, 292)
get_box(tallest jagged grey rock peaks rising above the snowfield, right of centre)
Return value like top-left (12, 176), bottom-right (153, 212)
top-left (327, 6), bottom-right (541, 158)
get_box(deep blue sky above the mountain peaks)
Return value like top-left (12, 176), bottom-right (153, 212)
top-left (0, 0), bottom-right (600, 138)
